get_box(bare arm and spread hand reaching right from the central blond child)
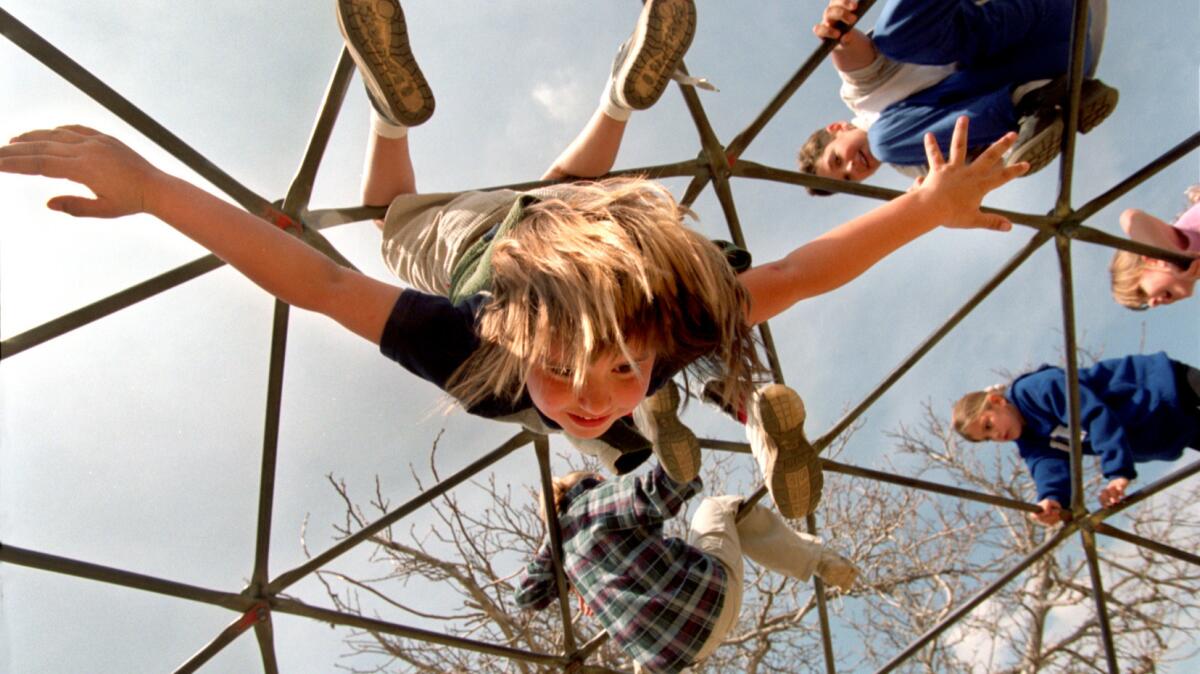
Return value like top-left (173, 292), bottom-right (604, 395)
top-left (738, 116), bottom-right (1028, 324)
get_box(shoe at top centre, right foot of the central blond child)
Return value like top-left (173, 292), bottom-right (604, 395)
top-left (612, 0), bottom-right (696, 110)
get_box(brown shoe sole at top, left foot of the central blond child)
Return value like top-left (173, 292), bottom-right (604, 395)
top-left (337, 0), bottom-right (433, 126)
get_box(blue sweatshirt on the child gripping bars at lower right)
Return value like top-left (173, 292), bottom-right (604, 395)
top-left (1007, 353), bottom-right (1200, 506)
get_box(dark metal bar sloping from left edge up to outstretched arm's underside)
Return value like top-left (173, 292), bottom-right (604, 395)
top-left (0, 255), bottom-right (224, 360)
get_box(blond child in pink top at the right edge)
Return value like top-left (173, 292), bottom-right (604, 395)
top-left (1109, 185), bottom-right (1200, 311)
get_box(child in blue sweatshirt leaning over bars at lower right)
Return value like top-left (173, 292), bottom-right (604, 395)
top-left (953, 353), bottom-right (1200, 524)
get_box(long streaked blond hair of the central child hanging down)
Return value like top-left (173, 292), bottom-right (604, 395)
top-left (449, 177), bottom-right (763, 409)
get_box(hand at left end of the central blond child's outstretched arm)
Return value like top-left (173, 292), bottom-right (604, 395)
top-left (0, 125), bottom-right (163, 217)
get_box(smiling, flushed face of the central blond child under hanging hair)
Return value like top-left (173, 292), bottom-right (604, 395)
top-left (526, 344), bottom-right (655, 439)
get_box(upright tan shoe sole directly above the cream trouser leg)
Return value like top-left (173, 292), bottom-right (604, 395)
top-left (755, 384), bottom-right (824, 519)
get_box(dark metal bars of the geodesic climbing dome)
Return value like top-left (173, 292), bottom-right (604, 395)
top-left (0, 0), bottom-right (1200, 672)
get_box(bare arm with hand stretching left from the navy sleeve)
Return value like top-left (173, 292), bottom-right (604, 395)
top-left (0, 126), bottom-right (401, 343)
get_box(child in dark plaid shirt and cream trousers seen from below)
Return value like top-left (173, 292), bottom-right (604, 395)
top-left (516, 455), bottom-right (858, 673)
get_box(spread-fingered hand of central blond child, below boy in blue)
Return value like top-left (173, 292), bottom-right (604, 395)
top-left (916, 116), bottom-right (1030, 231)
